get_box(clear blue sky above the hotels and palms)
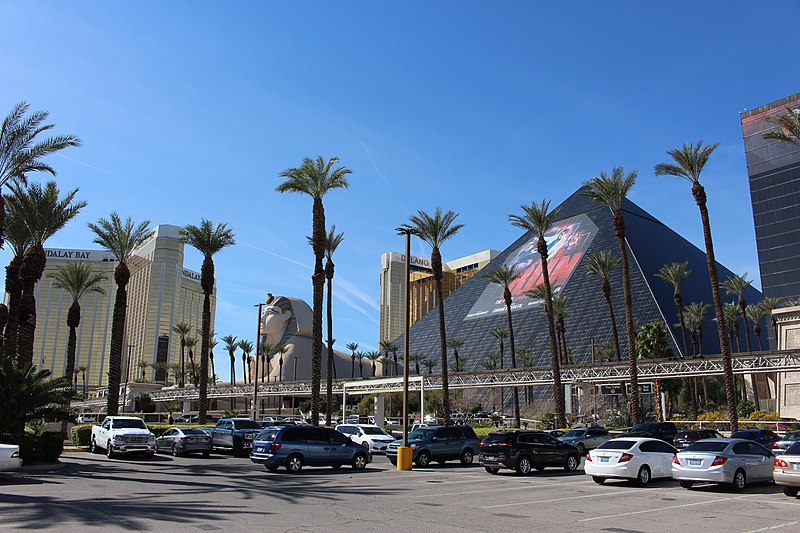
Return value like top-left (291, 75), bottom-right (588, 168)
top-left (0, 1), bottom-right (800, 378)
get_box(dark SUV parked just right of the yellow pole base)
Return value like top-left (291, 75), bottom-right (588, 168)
top-left (386, 426), bottom-right (480, 466)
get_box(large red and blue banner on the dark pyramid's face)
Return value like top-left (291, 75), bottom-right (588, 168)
top-left (464, 214), bottom-right (597, 320)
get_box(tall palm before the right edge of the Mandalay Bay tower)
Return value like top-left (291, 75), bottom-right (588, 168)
top-left (181, 218), bottom-right (236, 424)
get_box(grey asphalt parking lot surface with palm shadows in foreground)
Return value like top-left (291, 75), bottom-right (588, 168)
top-left (0, 453), bottom-right (800, 532)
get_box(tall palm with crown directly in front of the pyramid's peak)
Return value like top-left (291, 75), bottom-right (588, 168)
top-left (581, 167), bottom-right (641, 424)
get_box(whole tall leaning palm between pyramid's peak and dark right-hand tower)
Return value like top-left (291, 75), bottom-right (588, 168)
top-left (655, 140), bottom-right (739, 431)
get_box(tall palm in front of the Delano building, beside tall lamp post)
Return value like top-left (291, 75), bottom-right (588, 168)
top-left (403, 207), bottom-right (464, 424)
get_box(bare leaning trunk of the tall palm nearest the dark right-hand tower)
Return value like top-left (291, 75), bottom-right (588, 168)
top-left (692, 181), bottom-right (739, 432)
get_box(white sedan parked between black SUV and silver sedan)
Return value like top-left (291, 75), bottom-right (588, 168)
top-left (583, 437), bottom-right (677, 486)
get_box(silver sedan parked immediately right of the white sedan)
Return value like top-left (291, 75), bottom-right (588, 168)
top-left (672, 438), bottom-right (773, 491)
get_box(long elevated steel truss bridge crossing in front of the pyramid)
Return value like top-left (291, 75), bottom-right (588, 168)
top-left (120, 350), bottom-right (800, 407)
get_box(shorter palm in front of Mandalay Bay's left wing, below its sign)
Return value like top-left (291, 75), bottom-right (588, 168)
top-left (47, 262), bottom-right (108, 388)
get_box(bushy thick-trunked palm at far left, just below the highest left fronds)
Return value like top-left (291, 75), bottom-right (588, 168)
top-left (6, 181), bottom-right (86, 364)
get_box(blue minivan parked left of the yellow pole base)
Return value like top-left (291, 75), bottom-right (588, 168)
top-left (250, 426), bottom-right (372, 473)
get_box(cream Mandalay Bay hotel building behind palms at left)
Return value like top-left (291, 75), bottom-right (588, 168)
top-left (33, 224), bottom-right (216, 389)
